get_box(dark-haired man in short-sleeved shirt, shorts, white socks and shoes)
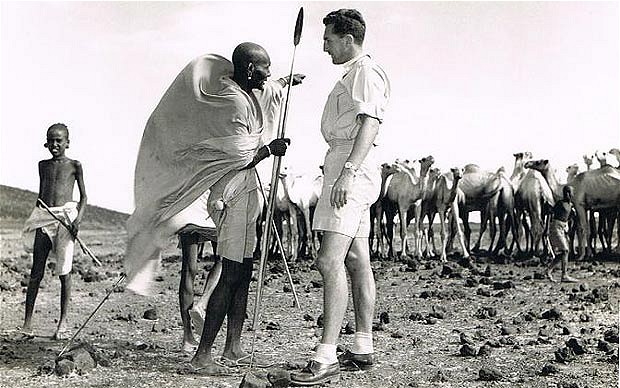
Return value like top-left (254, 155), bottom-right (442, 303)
top-left (291, 9), bottom-right (390, 386)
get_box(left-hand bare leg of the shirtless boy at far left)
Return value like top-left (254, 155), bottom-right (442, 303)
top-left (22, 229), bottom-right (52, 335)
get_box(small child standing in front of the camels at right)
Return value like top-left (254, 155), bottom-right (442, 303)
top-left (547, 185), bottom-right (577, 283)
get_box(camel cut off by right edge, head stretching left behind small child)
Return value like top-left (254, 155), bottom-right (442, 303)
top-left (526, 160), bottom-right (620, 260)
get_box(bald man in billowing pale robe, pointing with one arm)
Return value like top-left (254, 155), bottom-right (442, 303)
top-left (125, 43), bottom-right (304, 374)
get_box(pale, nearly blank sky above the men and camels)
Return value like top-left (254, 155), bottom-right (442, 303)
top-left (0, 1), bottom-right (620, 213)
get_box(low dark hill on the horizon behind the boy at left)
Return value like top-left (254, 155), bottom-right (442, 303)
top-left (0, 185), bottom-right (129, 229)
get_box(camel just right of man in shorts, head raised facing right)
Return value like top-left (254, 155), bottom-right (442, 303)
top-left (386, 156), bottom-right (435, 257)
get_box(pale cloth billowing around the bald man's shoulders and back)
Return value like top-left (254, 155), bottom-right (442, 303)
top-left (125, 54), bottom-right (282, 294)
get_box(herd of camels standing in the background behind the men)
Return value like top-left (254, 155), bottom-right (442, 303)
top-left (266, 148), bottom-right (620, 261)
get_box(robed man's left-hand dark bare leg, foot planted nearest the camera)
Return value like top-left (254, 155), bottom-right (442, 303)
top-left (191, 257), bottom-right (245, 374)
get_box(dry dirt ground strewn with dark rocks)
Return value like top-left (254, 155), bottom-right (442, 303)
top-left (0, 224), bottom-right (620, 388)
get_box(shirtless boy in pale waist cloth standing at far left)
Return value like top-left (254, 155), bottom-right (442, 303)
top-left (22, 124), bottom-right (86, 339)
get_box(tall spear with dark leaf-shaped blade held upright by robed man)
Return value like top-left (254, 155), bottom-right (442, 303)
top-left (250, 7), bottom-right (304, 369)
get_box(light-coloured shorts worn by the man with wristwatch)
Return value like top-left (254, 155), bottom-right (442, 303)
top-left (312, 143), bottom-right (381, 238)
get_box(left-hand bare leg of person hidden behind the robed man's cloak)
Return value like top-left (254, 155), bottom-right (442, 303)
top-left (179, 234), bottom-right (198, 352)
